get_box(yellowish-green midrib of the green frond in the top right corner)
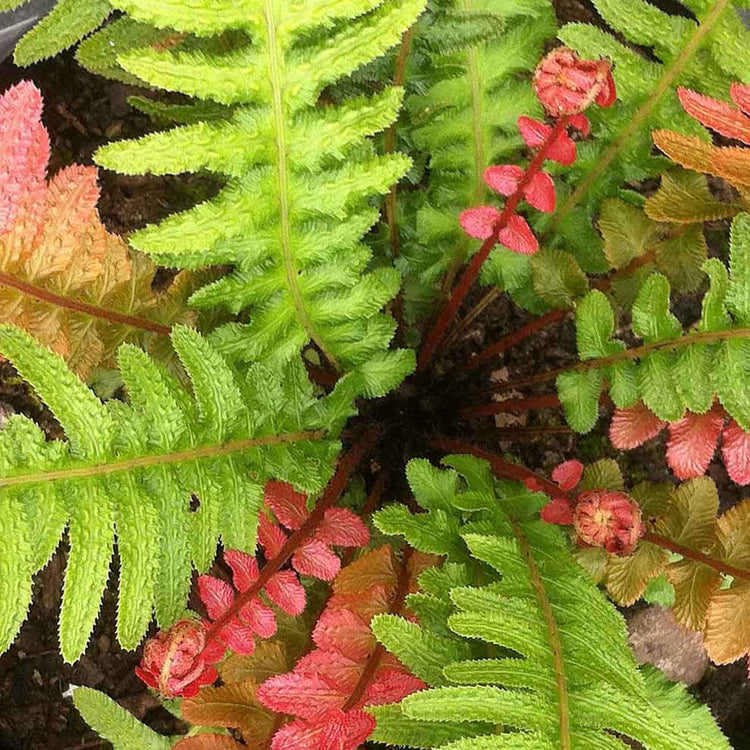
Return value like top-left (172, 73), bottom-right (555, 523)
top-left (544, 0), bottom-right (729, 237)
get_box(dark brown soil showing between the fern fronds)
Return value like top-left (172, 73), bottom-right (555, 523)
top-left (0, 0), bottom-right (750, 750)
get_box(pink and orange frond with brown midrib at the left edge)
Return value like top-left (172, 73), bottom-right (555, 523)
top-left (0, 81), bottom-right (195, 378)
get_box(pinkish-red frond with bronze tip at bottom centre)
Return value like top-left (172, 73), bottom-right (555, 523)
top-left (256, 546), bottom-right (434, 750)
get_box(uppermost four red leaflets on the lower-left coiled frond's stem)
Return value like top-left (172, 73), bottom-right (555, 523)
top-left (258, 481), bottom-right (370, 581)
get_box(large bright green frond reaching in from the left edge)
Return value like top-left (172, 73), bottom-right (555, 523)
top-left (0, 326), bottom-right (358, 661)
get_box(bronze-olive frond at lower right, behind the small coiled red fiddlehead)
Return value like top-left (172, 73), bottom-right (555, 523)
top-left (553, 459), bottom-right (750, 664)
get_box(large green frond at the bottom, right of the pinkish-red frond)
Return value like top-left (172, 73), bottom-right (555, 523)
top-left (371, 456), bottom-right (728, 750)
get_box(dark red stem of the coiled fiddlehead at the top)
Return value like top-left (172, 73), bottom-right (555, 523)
top-left (417, 115), bottom-right (570, 370)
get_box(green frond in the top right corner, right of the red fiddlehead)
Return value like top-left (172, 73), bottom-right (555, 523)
top-left (553, 0), bottom-right (750, 273)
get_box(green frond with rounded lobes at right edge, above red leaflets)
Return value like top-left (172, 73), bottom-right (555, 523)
top-left (557, 214), bottom-right (750, 432)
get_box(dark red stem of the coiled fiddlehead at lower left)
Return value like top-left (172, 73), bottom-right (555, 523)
top-left (206, 428), bottom-right (381, 642)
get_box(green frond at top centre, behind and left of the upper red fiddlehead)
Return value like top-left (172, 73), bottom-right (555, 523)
top-left (399, 0), bottom-right (555, 317)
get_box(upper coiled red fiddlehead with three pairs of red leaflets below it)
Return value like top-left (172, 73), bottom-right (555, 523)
top-left (460, 47), bottom-right (615, 255)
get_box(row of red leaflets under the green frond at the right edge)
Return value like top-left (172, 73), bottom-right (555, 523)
top-left (609, 401), bottom-right (750, 485)
